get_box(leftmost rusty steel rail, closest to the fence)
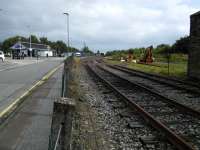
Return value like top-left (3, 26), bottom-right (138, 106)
top-left (88, 65), bottom-right (197, 150)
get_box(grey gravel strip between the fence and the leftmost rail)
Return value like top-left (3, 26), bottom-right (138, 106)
top-left (80, 64), bottom-right (173, 150)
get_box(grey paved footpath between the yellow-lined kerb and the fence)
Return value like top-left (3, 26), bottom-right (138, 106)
top-left (0, 67), bottom-right (62, 150)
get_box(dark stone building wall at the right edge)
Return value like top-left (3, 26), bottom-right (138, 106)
top-left (188, 11), bottom-right (200, 80)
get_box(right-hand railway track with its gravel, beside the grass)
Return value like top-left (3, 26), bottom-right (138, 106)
top-left (98, 64), bottom-right (200, 112)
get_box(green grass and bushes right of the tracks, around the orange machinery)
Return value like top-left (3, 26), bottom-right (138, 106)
top-left (106, 36), bottom-right (189, 77)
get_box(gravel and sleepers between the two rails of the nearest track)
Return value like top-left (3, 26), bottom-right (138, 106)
top-left (96, 65), bottom-right (200, 149)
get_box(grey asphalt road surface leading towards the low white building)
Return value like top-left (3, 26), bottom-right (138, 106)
top-left (0, 58), bottom-right (63, 112)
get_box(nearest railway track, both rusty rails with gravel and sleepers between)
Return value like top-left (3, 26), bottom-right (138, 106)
top-left (89, 61), bottom-right (200, 150)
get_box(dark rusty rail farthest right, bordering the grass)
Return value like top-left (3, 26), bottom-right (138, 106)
top-left (106, 64), bottom-right (200, 94)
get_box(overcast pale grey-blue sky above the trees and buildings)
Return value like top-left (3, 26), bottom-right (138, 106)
top-left (0, 0), bottom-right (200, 51)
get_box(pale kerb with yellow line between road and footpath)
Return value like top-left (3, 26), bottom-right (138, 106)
top-left (0, 64), bottom-right (62, 125)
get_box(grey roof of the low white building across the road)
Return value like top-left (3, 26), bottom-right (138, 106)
top-left (11, 42), bottom-right (51, 50)
